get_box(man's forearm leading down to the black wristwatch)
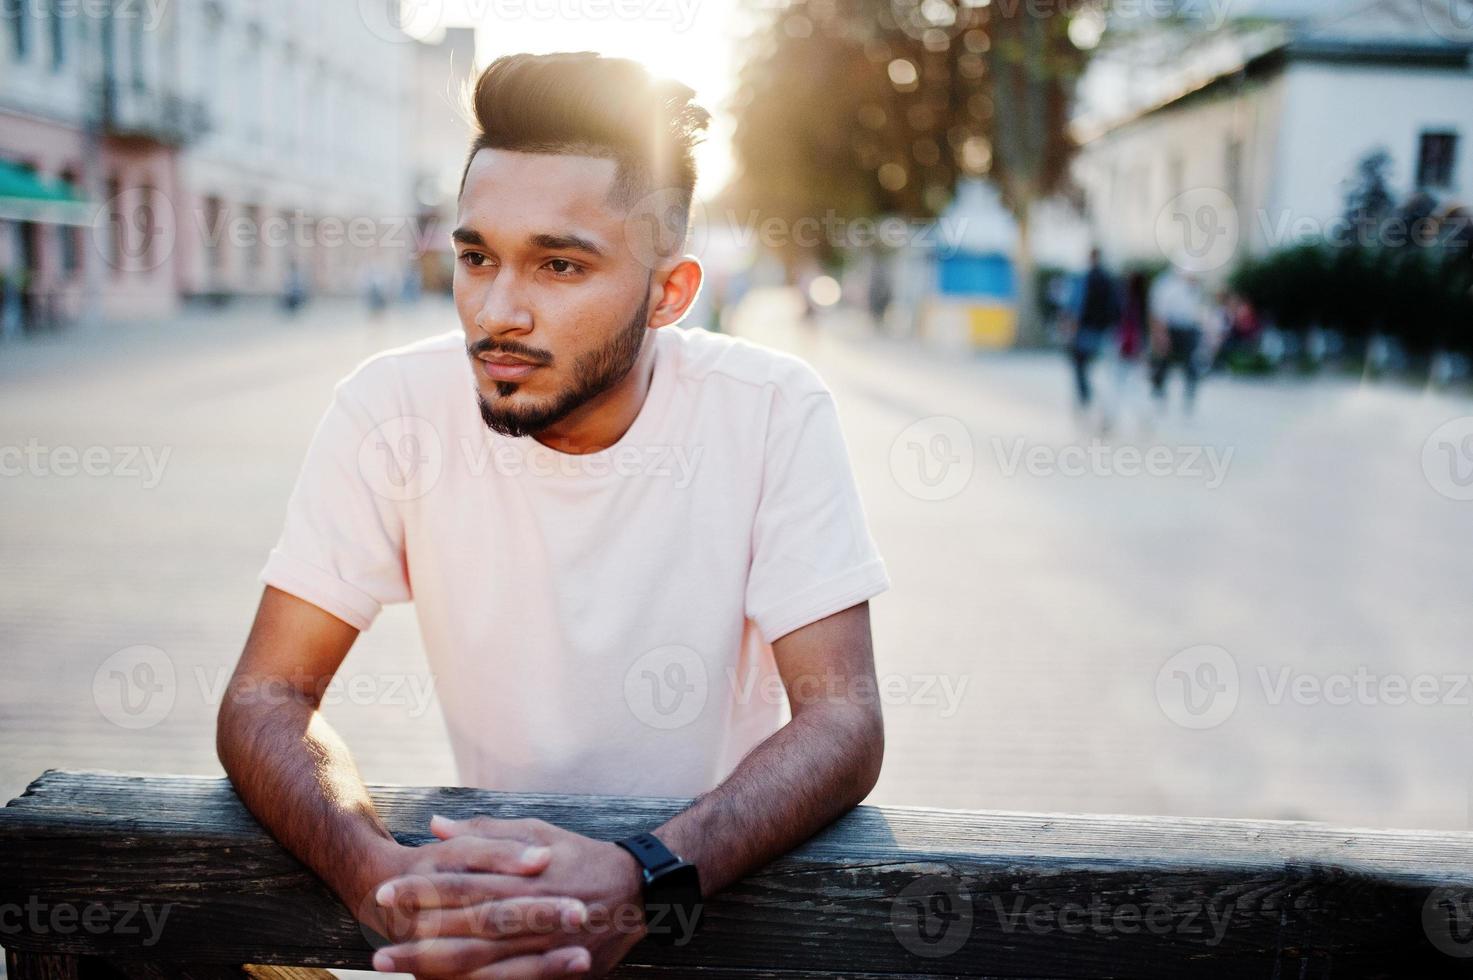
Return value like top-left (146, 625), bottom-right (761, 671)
top-left (654, 706), bottom-right (884, 895)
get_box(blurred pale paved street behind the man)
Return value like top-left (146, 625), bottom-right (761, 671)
top-left (0, 295), bottom-right (1473, 828)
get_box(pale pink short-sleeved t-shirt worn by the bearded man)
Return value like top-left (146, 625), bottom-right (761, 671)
top-left (261, 327), bottom-right (890, 796)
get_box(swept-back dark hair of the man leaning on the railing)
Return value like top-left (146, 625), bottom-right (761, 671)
top-left (461, 52), bottom-right (710, 250)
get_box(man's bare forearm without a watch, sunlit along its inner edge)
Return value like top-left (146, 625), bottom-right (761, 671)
top-left (217, 684), bottom-right (399, 914)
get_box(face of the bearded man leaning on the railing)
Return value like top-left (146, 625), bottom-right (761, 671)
top-left (454, 149), bottom-right (651, 436)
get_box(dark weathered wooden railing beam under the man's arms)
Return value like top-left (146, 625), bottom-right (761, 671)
top-left (0, 771), bottom-right (1473, 980)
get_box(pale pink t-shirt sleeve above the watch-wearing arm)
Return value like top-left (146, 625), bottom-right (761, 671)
top-left (747, 374), bottom-right (890, 643)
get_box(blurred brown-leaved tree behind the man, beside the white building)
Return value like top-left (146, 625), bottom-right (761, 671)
top-left (734, 0), bottom-right (1086, 337)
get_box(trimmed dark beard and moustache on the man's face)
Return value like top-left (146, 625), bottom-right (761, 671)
top-left (467, 282), bottom-right (650, 439)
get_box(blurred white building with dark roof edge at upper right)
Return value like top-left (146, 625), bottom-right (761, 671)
top-left (1075, 0), bottom-right (1473, 276)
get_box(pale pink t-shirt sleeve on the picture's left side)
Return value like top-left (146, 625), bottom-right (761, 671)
top-left (261, 383), bottom-right (409, 631)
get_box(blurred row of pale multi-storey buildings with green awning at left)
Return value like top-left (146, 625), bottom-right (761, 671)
top-left (0, 0), bottom-right (417, 327)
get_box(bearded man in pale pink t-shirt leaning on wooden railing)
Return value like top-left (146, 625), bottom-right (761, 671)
top-left (218, 53), bottom-right (888, 977)
